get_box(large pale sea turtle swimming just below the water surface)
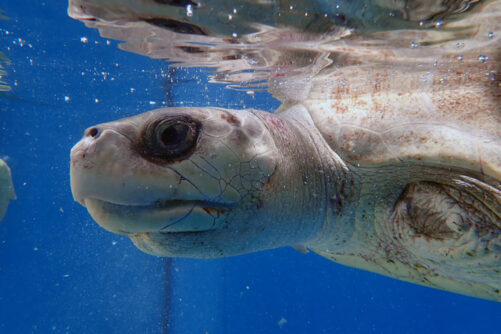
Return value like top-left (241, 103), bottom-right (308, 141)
top-left (71, 53), bottom-right (501, 301)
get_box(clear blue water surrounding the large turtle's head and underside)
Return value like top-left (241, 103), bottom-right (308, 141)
top-left (0, 0), bottom-right (501, 334)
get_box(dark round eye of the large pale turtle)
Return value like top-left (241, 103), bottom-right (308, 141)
top-left (140, 116), bottom-right (200, 162)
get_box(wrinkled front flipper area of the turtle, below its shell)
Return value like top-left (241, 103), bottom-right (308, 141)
top-left (318, 175), bottom-right (501, 302)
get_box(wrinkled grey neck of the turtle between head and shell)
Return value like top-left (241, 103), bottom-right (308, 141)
top-left (252, 105), bottom-right (353, 249)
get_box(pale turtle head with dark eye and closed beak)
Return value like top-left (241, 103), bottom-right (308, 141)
top-left (70, 108), bottom-right (314, 258)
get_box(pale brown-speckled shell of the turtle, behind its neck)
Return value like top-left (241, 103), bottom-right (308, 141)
top-left (303, 59), bottom-right (501, 181)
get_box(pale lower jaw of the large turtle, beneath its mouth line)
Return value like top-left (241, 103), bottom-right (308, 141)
top-left (82, 198), bottom-right (231, 235)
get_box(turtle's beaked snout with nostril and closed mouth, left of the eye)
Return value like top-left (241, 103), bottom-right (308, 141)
top-left (70, 123), bottom-right (236, 234)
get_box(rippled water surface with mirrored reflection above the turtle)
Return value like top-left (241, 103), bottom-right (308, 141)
top-left (68, 0), bottom-right (501, 93)
